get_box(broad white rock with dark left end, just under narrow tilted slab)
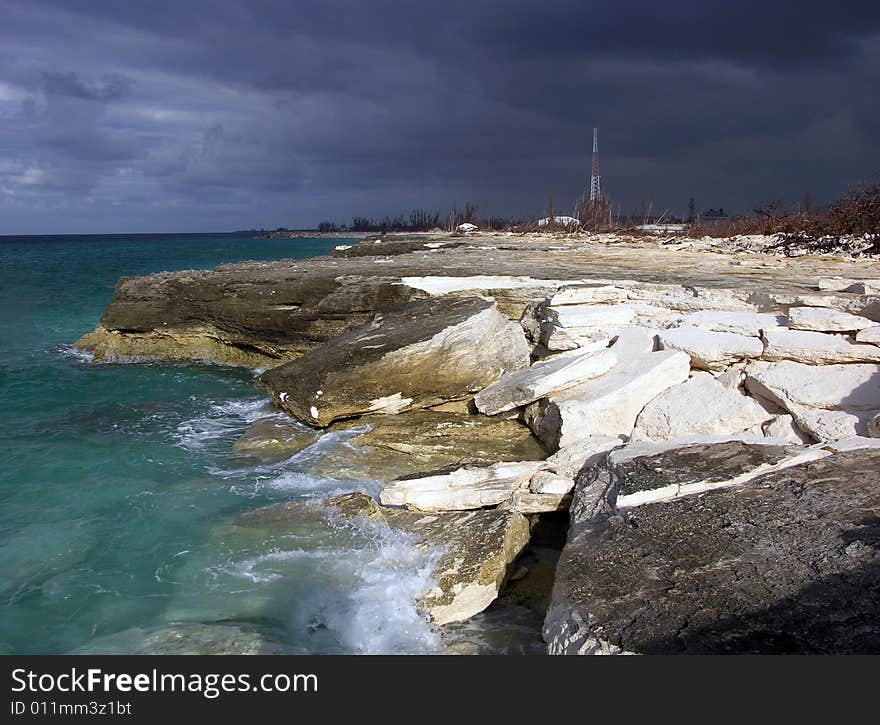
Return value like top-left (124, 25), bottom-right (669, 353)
top-left (525, 350), bottom-right (690, 451)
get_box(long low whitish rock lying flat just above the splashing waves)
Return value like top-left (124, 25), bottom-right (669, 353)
top-left (380, 461), bottom-right (544, 511)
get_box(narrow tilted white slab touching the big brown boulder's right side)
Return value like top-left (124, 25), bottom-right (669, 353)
top-left (474, 349), bottom-right (618, 415)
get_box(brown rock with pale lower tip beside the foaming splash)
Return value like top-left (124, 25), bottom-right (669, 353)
top-left (327, 493), bottom-right (529, 625)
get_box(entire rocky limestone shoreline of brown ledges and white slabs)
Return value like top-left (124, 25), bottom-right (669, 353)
top-left (77, 234), bottom-right (880, 654)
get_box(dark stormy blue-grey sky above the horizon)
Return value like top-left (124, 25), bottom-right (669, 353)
top-left (0, 0), bottom-right (880, 234)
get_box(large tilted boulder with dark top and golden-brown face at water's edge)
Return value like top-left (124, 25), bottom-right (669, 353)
top-left (259, 297), bottom-right (529, 427)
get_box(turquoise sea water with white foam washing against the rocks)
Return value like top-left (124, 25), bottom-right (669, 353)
top-left (0, 234), bottom-right (536, 653)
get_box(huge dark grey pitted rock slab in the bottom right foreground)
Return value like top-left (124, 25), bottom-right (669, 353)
top-left (544, 450), bottom-right (880, 654)
